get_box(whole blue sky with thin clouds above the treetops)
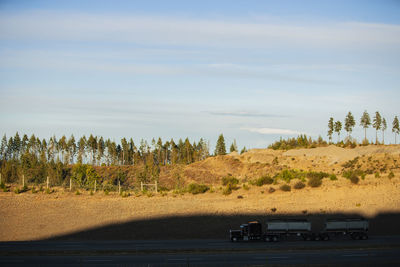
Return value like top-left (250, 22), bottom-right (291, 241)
top-left (0, 0), bottom-right (400, 152)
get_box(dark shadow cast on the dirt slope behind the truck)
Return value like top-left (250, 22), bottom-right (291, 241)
top-left (45, 213), bottom-right (400, 240)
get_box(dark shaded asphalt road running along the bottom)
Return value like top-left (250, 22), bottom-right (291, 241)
top-left (0, 236), bottom-right (400, 266)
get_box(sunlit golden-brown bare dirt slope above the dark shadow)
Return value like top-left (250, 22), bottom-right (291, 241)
top-left (0, 146), bottom-right (400, 241)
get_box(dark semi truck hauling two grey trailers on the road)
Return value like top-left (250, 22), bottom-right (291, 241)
top-left (229, 219), bottom-right (369, 242)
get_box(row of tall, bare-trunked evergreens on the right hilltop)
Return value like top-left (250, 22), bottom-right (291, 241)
top-left (327, 110), bottom-right (400, 144)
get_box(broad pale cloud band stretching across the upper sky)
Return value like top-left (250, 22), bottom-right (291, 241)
top-left (0, 11), bottom-right (400, 47)
